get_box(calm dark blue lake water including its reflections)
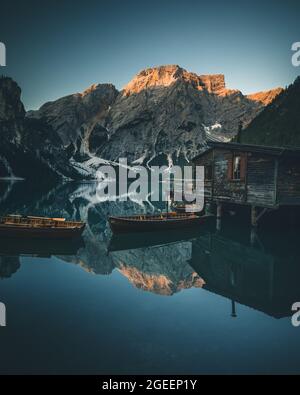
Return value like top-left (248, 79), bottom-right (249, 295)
top-left (0, 183), bottom-right (300, 374)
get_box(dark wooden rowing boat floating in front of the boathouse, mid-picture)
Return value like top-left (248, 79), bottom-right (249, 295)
top-left (109, 212), bottom-right (212, 233)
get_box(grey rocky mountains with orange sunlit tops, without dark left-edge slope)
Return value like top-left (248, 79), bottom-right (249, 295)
top-left (27, 65), bottom-right (280, 167)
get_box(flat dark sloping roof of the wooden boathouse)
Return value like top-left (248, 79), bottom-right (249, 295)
top-left (192, 141), bottom-right (300, 161)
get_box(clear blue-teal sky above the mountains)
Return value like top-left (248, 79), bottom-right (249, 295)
top-left (0, 0), bottom-right (300, 110)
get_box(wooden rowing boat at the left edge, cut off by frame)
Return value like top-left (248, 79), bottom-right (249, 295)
top-left (0, 215), bottom-right (85, 239)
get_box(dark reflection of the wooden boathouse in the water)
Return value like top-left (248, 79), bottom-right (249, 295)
top-left (190, 233), bottom-right (300, 318)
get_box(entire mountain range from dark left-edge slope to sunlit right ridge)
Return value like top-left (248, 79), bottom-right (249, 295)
top-left (0, 65), bottom-right (282, 179)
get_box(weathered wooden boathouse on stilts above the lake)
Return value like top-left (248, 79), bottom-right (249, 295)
top-left (193, 142), bottom-right (300, 225)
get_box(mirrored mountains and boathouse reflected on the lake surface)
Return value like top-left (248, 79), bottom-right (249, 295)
top-left (0, 183), bottom-right (300, 318)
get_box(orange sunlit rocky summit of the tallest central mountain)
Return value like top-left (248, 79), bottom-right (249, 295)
top-left (123, 65), bottom-right (226, 96)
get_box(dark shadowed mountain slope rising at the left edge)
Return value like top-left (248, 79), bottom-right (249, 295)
top-left (0, 77), bottom-right (79, 184)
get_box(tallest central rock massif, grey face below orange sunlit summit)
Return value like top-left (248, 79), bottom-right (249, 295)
top-left (99, 66), bottom-right (274, 162)
